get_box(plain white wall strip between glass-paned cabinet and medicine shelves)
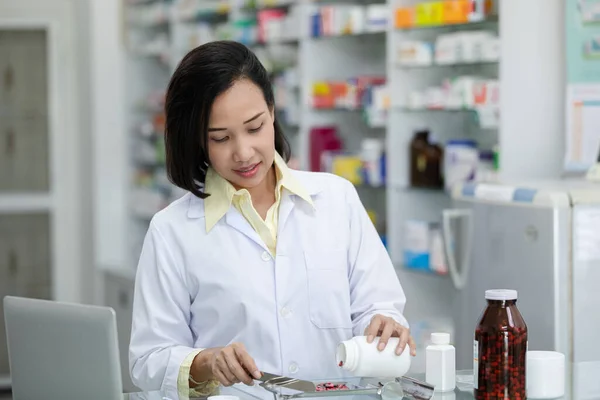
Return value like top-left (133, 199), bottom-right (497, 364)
top-left (90, 0), bottom-right (128, 278)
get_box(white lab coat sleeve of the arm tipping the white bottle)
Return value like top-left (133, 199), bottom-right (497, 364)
top-left (346, 182), bottom-right (409, 336)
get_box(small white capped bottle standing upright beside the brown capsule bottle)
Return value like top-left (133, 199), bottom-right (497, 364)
top-left (425, 333), bottom-right (456, 392)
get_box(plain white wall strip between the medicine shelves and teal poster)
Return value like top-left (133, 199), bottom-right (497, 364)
top-left (500, 0), bottom-right (566, 181)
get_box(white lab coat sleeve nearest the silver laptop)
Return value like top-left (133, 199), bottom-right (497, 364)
top-left (129, 222), bottom-right (197, 392)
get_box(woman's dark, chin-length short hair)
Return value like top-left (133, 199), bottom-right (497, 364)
top-left (165, 40), bottom-right (291, 199)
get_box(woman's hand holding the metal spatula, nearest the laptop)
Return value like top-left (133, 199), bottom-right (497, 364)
top-left (209, 343), bottom-right (262, 386)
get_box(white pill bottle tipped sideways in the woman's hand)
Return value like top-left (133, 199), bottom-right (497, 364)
top-left (336, 336), bottom-right (410, 378)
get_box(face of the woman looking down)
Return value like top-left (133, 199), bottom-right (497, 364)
top-left (208, 79), bottom-right (275, 189)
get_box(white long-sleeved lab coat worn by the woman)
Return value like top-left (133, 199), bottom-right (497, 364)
top-left (129, 171), bottom-right (408, 390)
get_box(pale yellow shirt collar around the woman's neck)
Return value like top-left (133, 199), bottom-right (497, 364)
top-left (204, 152), bottom-right (314, 232)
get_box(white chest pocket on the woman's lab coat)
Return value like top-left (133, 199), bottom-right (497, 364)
top-left (304, 249), bottom-right (352, 329)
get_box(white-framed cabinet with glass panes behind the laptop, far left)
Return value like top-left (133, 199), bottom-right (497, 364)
top-left (0, 0), bottom-right (96, 389)
